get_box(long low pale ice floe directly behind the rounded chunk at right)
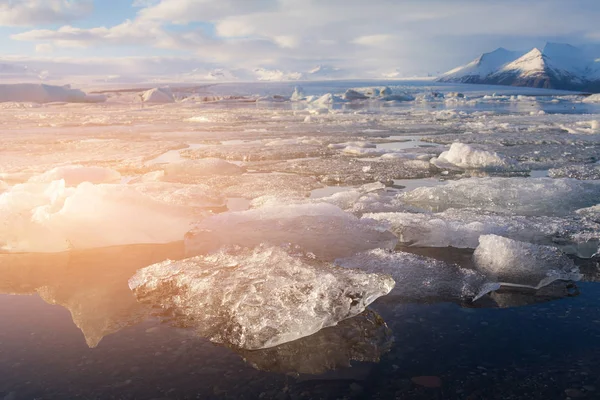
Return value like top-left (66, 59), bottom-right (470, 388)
top-left (364, 209), bottom-right (600, 258)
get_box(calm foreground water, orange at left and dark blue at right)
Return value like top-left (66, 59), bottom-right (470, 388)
top-left (0, 243), bottom-right (600, 400)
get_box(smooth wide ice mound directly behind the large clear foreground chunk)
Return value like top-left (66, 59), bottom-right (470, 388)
top-left (186, 203), bottom-right (398, 261)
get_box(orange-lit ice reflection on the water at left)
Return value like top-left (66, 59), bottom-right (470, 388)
top-left (0, 242), bottom-right (184, 348)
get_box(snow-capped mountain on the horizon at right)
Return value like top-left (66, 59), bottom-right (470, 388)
top-left (438, 43), bottom-right (600, 93)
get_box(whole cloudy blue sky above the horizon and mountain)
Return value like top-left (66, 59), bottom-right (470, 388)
top-left (0, 0), bottom-right (600, 80)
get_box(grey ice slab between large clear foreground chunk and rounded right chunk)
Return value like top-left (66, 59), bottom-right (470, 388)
top-left (335, 249), bottom-right (499, 301)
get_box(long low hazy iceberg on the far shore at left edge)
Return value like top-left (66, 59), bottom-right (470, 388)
top-left (0, 83), bottom-right (106, 103)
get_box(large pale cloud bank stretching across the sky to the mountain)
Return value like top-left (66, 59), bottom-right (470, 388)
top-left (9, 0), bottom-right (600, 76)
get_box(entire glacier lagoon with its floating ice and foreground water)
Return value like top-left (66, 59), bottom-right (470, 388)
top-left (0, 81), bottom-right (600, 399)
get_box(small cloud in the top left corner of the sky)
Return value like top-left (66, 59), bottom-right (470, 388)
top-left (0, 0), bottom-right (93, 26)
